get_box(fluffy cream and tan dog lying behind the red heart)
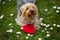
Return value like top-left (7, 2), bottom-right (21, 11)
top-left (16, 3), bottom-right (40, 30)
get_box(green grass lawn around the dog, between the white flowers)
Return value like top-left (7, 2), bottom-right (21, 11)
top-left (0, 0), bottom-right (60, 40)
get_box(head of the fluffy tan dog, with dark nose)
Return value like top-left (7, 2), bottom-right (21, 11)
top-left (19, 3), bottom-right (38, 21)
